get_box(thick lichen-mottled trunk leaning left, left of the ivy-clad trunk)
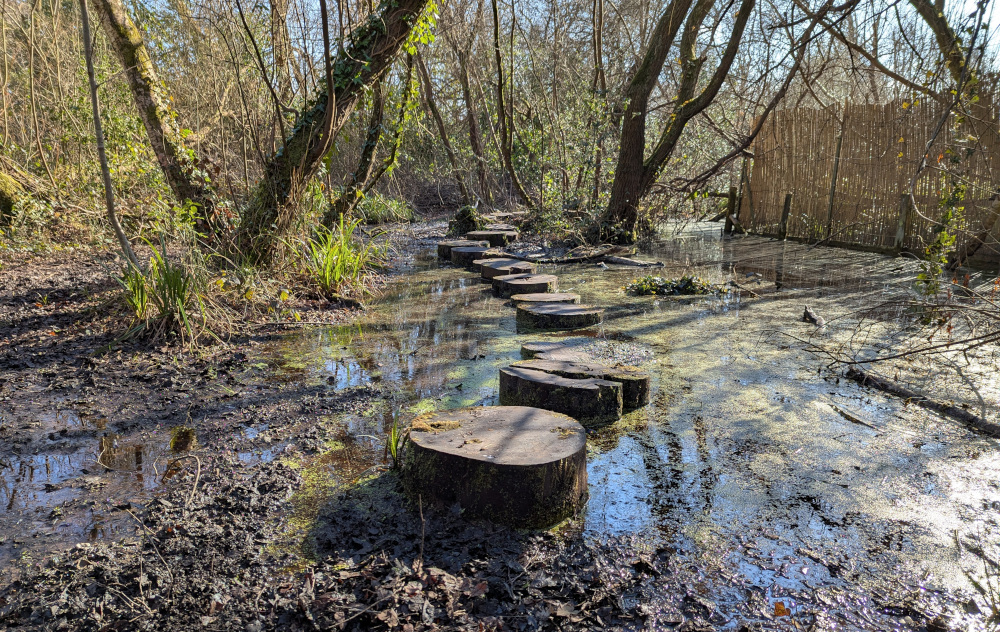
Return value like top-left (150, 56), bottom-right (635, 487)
top-left (94, 0), bottom-right (225, 240)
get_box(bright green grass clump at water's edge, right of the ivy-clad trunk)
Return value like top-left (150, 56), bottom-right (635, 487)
top-left (302, 216), bottom-right (383, 297)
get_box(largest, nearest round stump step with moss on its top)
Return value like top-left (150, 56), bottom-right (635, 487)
top-left (403, 406), bottom-right (587, 528)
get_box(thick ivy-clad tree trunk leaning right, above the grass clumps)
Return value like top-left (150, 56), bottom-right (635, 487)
top-left (242, 0), bottom-right (428, 263)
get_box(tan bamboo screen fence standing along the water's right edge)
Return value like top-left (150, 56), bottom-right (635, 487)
top-left (740, 89), bottom-right (1000, 263)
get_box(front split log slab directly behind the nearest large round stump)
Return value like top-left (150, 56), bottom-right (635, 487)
top-left (500, 366), bottom-right (622, 428)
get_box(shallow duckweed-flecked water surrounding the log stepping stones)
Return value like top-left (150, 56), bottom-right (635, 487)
top-left (266, 223), bottom-right (1000, 628)
